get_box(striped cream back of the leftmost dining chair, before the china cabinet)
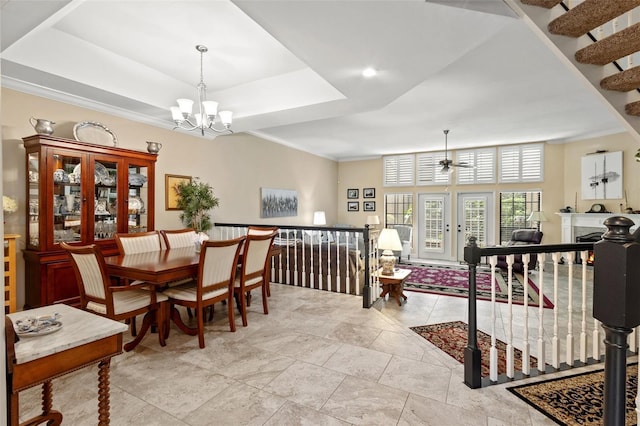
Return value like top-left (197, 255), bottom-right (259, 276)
top-left (60, 243), bottom-right (113, 314)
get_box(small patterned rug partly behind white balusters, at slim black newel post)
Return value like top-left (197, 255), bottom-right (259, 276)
top-left (410, 321), bottom-right (538, 377)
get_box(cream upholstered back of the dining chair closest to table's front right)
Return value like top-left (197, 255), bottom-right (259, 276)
top-left (199, 237), bottom-right (245, 295)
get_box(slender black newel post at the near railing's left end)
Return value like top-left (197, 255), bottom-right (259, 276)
top-left (464, 236), bottom-right (482, 389)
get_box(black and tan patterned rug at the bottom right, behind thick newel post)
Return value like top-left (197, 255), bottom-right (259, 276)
top-left (507, 364), bottom-right (638, 426)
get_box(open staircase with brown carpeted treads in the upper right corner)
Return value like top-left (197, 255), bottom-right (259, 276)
top-left (504, 0), bottom-right (640, 141)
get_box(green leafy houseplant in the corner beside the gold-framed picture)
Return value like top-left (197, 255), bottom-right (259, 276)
top-left (176, 179), bottom-right (220, 233)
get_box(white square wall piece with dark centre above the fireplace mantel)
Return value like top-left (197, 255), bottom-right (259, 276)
top-left (580, 151), bottom-right (624, 200)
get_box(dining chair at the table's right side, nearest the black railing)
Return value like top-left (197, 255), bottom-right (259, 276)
top-left (234, 230), bottom-right (278, 327)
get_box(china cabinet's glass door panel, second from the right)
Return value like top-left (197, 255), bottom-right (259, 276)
top-left (93, 158), bottom-right (119, 241)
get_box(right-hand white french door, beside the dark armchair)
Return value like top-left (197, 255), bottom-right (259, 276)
top-left (456, 192), bottom-right (495, 261)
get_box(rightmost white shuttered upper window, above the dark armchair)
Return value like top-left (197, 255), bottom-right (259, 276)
top-left (500, 144), bottom-right (544, 182)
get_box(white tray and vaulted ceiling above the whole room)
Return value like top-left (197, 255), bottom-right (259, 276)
top-left (1, 0), bottom-right (624, 160)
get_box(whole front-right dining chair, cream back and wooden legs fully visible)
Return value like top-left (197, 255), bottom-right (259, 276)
top-left (163, 237), bottom-right (245, 348)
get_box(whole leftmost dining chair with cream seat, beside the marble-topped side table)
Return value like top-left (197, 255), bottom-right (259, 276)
top-left (60, 243), bottom-right (168, 351)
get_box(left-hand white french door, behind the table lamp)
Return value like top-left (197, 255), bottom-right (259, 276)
top-left (415, 193), bottom-right (451, 260)
